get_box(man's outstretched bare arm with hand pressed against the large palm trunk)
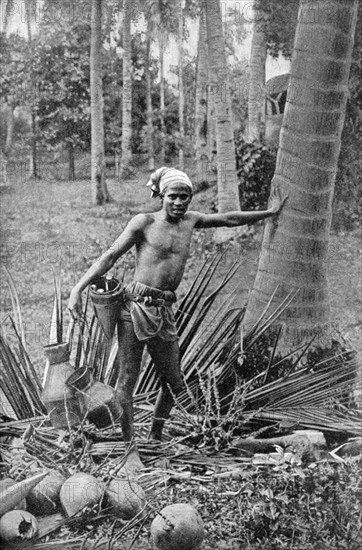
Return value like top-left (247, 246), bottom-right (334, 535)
top-left (195, 185), bottom-right (288, 227)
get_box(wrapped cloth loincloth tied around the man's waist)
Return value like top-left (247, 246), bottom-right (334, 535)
top-left (119, 281), bottom-right (177, 342)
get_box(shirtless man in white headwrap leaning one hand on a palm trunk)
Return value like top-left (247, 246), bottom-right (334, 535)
top-left (68, 168), bottom-right (286, 470)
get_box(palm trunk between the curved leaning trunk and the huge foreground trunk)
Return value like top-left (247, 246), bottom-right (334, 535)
top-left (248, 2), bottom-right (267, 141)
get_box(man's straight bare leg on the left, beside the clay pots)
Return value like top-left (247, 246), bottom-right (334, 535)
top-left (117, 320), bottom-right (144, 473)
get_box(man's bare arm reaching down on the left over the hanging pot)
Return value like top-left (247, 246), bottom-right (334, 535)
top-left (68, 214), bottom-right (144, 318)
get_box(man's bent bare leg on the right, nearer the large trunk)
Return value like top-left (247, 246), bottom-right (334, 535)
top-left (147, 338), bottom-right (184, 441)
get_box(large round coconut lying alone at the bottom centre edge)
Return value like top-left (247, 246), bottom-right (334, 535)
top-left (151, 503), bottom-right (205, 550)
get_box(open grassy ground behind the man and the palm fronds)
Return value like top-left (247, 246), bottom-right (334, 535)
top-left (0, 167), bottom-right (362, 384)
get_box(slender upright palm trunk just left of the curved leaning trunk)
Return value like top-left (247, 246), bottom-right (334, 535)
top-left (195, 10), bottom-right (210, 183)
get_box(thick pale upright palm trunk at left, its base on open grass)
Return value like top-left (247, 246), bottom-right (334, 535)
top-left (90, 0), bottom-right (110, 204)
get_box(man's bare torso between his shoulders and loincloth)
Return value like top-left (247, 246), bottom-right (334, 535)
top-left (134, 212), bottom-right (197, 290)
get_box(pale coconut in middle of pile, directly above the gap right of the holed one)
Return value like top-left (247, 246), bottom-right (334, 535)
top-left (60, 473), bottom-right (104, 516)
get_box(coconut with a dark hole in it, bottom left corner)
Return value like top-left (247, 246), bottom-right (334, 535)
top-left (0, 510), bottom-right (39, 541)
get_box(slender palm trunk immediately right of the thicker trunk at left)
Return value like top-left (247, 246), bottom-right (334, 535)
top-left (121, 0), bottom-right (132, 177)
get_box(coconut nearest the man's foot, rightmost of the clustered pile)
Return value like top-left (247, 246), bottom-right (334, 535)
top-left (106, 479), bottom-right (146, 521)
